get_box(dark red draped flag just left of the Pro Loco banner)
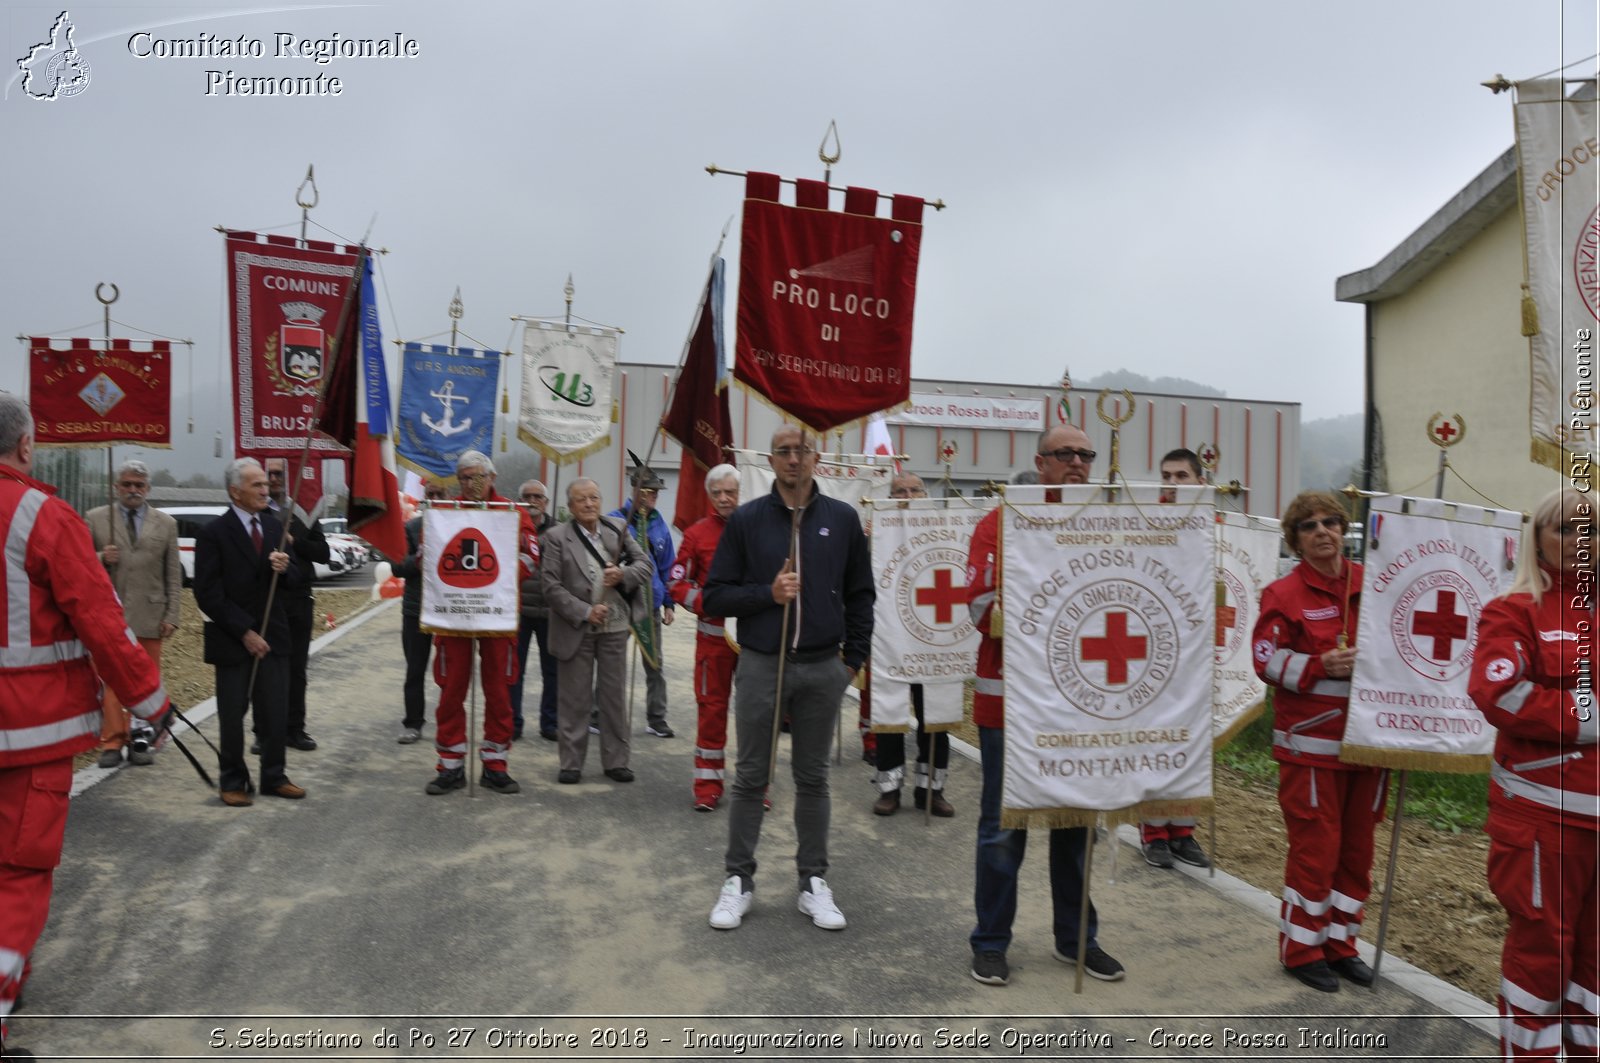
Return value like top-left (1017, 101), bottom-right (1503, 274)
top-left (661, 258), bottom-right (733, 532)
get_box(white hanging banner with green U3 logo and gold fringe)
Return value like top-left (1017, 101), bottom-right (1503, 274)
top-left (517, 320), bottom-right (618, 464)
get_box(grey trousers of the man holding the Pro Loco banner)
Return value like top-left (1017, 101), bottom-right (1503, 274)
top-left (725, 648), bottom-right (850, 885)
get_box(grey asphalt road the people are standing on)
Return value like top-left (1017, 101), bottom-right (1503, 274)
top-left (14, 601), bottom-right (1494, 1060)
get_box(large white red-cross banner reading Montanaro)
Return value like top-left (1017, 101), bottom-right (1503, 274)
top-left (1000, 485), bottom-right (1216, 828)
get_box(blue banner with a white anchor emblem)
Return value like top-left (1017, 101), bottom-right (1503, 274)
top-left (395, 343), bottom-right (501, 480)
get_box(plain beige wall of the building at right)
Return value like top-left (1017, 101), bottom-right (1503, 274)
top-left (1370, 210), bottom-right (1560, 511)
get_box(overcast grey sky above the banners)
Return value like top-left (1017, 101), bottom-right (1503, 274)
top-left (0, 0), bottom-right (1600, 464)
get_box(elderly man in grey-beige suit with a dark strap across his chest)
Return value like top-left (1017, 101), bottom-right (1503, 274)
top-left (539, 479), bottom-right (650, 783)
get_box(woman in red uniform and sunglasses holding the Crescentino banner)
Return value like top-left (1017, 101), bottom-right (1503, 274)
top-left (1253, 491), bottom-right (1389, 993)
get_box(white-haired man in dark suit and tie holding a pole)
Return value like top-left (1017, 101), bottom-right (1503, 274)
top-left (194, 458), bottom-right (307, 808)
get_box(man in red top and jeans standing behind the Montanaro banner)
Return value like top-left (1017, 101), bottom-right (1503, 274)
top-left (966, 424), bottom-right (1125, 986)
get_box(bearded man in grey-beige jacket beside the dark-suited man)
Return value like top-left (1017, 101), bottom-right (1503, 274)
top-left (88, 458), bottom-right (184, 768)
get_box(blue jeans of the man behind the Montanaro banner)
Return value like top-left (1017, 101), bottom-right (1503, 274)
top-left (970, 727), bottom-right (1099, 956)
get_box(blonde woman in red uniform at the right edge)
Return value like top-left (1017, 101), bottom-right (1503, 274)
top-left (1467, 488), bottom-right (1600, 1060)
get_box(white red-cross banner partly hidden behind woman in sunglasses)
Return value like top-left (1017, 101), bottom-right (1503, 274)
top-left (1211, 511), bottom-right (1282, 749)
